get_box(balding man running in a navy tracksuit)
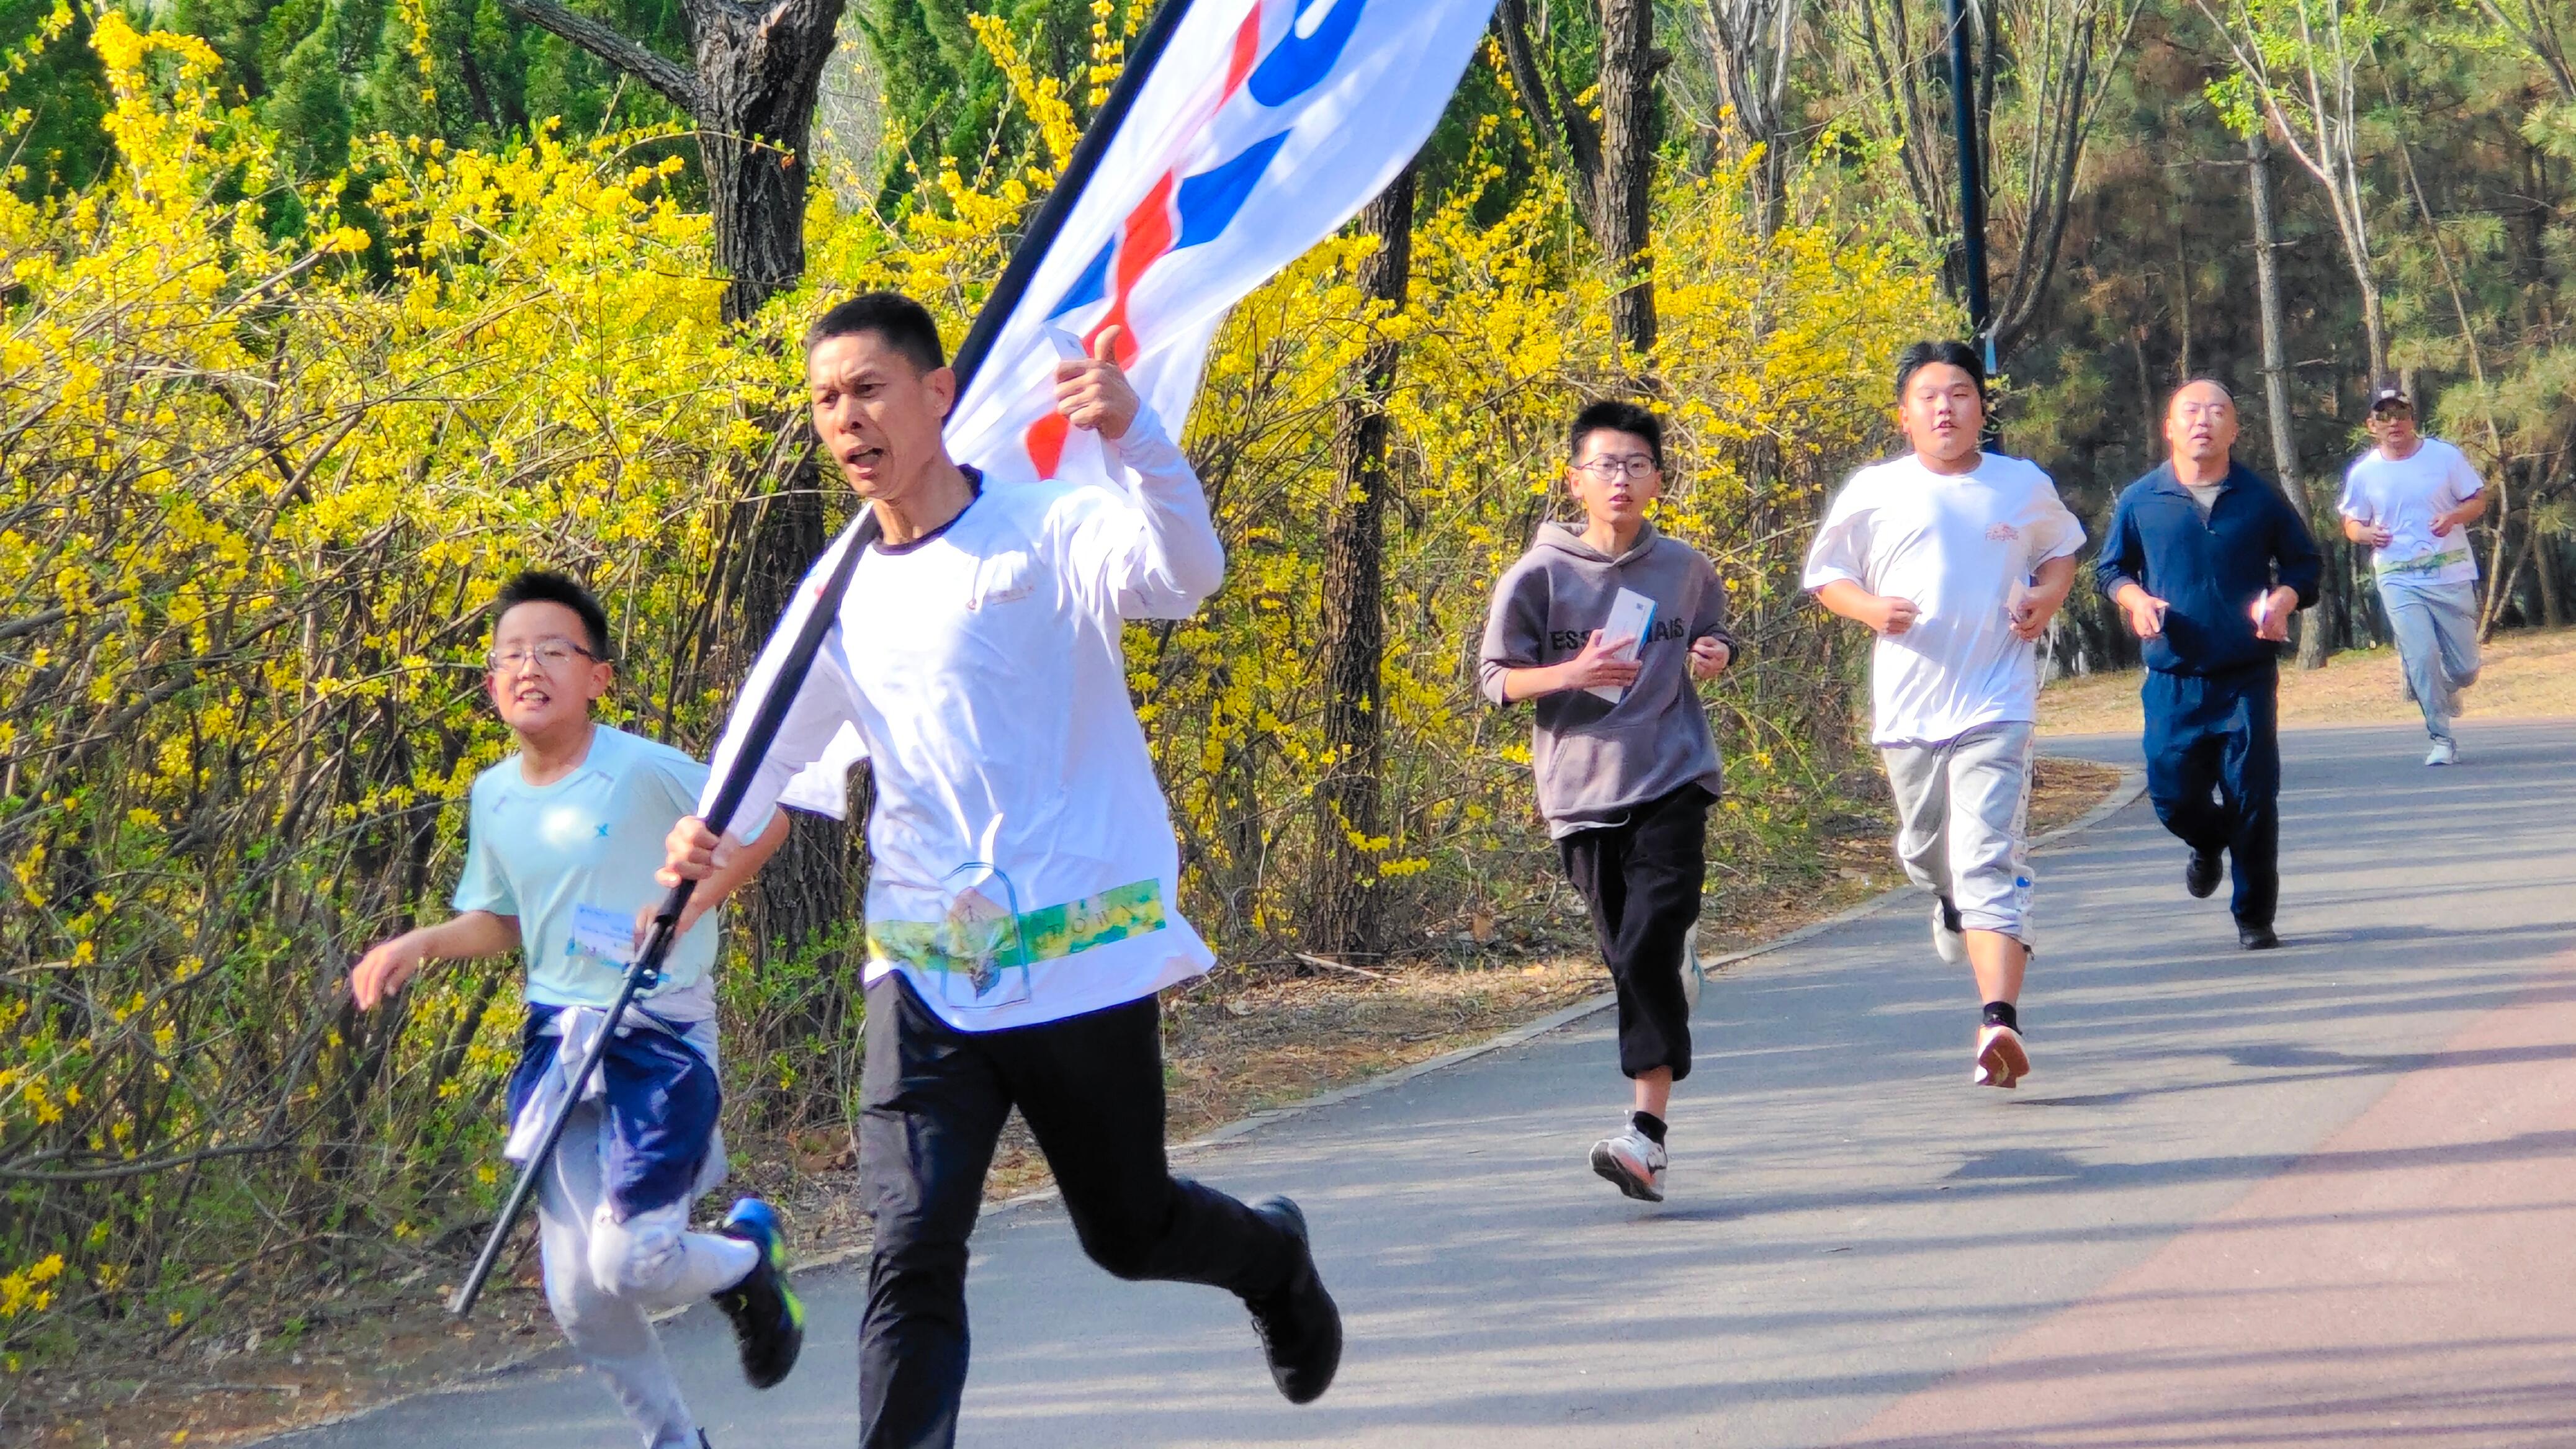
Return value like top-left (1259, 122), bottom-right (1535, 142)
top-left (2094, 379), bottom-right (2321, 949)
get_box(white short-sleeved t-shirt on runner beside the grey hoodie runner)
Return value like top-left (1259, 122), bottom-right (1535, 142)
top-left (1806, 453), bottom-right (2084, 744)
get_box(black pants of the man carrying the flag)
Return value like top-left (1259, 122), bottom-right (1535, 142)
top-left (858, 976), bottom-right (1301, 1449)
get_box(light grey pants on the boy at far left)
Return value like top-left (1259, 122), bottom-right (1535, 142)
top-left (536, 1101), bottom-right (760, 1449)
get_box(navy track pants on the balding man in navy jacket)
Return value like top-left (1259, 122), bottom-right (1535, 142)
top-left (2138, 664), bottom-right (2280, 926)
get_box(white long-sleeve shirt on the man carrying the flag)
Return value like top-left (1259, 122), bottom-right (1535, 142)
top-left (701, 409), bottom-right (1224, 1032)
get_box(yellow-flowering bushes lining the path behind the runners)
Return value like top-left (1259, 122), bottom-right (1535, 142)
top-left (0, 11), bottom-right (1942, 1366)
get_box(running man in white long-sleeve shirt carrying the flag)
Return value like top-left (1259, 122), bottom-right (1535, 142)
top-left (665, 294), bottom-right (1342, 1447)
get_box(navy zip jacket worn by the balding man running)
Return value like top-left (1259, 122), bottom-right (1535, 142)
top-left (2094, 464), bottom-right (2321, 675)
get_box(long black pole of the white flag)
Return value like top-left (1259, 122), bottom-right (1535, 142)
top-left (448, 0), bottom-right (1190, 1317)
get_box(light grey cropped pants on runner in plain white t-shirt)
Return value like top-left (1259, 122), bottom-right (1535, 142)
top-left (1878, 720), bottom-right (2035, 947)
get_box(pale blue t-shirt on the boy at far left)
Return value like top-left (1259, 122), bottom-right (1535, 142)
top-left (454, 726), bottom-right (716, 1014)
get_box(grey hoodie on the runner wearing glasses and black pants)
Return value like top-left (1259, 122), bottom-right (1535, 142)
top-left (1476, 523), bottom-right (1741, 839)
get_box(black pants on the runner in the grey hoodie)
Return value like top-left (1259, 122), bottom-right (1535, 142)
top-left (1556, 785), bottom-right (1708, 1081)
